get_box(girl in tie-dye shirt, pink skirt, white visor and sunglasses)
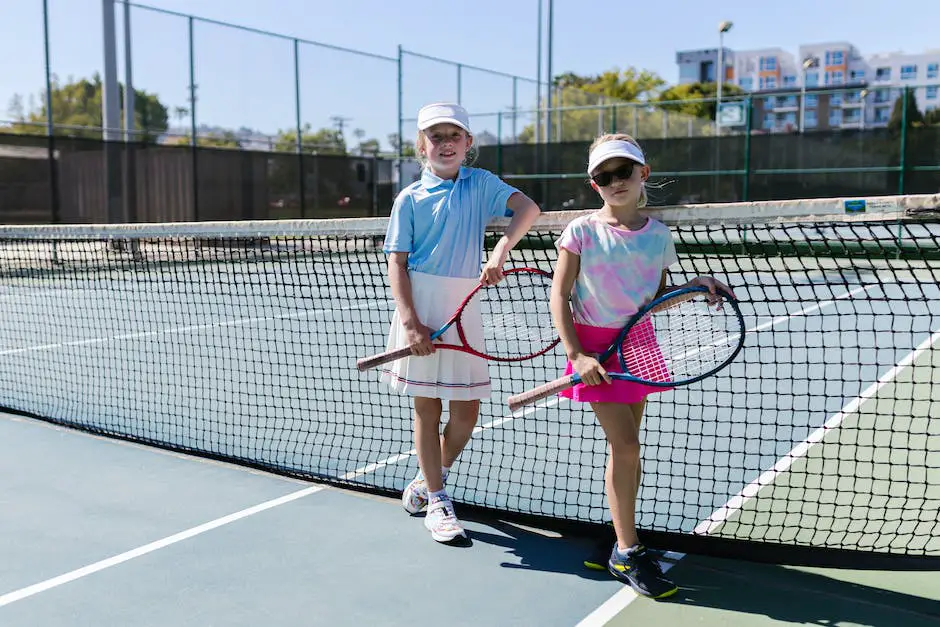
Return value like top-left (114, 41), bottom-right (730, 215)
top-left (551, 134), bottom-right (730, 598)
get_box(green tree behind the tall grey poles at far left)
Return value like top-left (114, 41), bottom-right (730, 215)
top-left (11, 73), bottom-right (168, 141)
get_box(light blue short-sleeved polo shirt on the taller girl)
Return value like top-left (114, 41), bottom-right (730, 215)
top-left (383, 167), bottom-right (519, 278)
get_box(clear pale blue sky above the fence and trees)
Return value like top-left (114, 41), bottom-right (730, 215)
top-left (0, 0), bottom-right (940, 146)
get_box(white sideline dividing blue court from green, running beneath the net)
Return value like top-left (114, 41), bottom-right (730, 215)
top-left (578, 314), bottom-right (940, 627)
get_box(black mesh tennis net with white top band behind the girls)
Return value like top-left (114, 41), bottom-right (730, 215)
top-left (0, 195), bottom-right (940, 568)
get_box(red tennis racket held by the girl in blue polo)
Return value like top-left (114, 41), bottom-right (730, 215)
top-left (356, 268), bottom-right (560, 370)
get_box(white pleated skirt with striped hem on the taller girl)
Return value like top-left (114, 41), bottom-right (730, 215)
top-left (381, 272), bottom-right (491, 401)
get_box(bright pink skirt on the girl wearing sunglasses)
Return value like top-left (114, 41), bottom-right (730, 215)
top-left (558, 323), bottom-right (673, 403)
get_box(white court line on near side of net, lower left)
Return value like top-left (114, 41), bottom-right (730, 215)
top-left (0, 486), bottom-right (326, 607)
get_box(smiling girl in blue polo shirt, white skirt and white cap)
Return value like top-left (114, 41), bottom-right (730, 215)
top-left (382, 103), bottom-right (539, 542)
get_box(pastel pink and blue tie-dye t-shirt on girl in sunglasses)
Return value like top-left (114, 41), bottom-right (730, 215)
top-left (556, 213), bottom-right (679, 328)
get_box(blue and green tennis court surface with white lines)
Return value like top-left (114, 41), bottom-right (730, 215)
top-left (0, 195), bottom-right (940, 625)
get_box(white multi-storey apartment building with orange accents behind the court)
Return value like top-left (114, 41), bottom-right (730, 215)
top-left (676, 42), bottom-right (940, 131)
